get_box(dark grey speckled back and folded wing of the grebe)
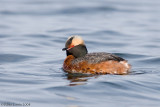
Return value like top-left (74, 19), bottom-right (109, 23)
top-left (72, 52), bottom-right (125, 64)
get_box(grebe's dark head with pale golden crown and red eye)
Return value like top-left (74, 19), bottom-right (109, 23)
top-left (62, 35), bottom-right (87, 58)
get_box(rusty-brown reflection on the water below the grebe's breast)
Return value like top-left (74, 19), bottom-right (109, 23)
top-left (66, 73), bottom-right (98, 86)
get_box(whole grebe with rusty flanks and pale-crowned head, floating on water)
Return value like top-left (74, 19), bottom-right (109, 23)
top-left (63, 36), bottom-right (131, 75)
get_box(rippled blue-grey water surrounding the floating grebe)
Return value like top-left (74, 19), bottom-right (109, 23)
top-left (0, 0), bottom-right (160, 107)
